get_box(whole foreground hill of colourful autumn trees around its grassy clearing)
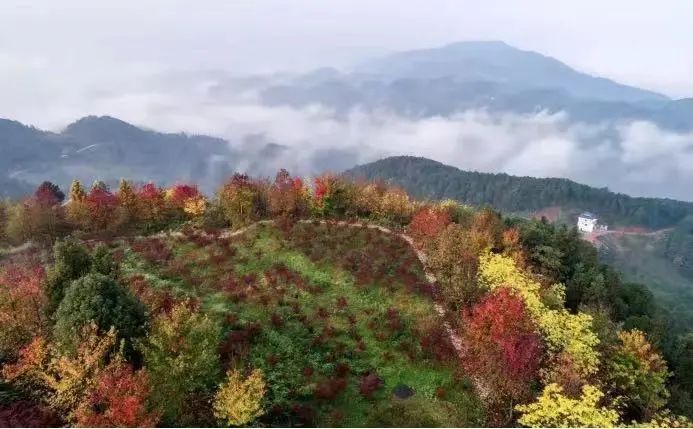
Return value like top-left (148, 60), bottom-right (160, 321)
top-left (0, 170), bottom-right (693, 427)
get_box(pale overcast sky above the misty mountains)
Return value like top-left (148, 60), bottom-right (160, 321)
top-left (0, 0), bottom-right (693, 127)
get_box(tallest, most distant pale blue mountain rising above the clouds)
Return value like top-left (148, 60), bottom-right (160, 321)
top-left (243, 41), bottom-right (693, 131)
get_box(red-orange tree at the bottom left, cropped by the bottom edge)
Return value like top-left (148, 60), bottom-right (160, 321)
top-left (75, 361), bottom-right (159, 427)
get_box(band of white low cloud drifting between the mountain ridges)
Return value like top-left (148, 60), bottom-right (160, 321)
top-left (1, 71), bottom-right (693, 200)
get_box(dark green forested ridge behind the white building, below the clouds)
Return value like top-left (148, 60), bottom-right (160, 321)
top-left (344, 156), bottom-right (693, 229)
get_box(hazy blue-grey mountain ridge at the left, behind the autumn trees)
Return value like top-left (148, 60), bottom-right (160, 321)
top-left (0, 116), bottom-right (241, 197)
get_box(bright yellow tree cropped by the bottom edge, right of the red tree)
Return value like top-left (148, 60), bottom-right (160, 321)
top-left (515, 384), bottom-right (619, 427)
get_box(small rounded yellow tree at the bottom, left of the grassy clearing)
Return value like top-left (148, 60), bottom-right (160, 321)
top-left (214, 369), bottom-right (266, 426)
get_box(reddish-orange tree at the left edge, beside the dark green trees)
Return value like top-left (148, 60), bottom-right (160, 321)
top-left (0, 265), bottom-right (48, 362)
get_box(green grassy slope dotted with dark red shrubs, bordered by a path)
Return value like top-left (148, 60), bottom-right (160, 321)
top-left (115, 224), bottom-right (483, 426)
